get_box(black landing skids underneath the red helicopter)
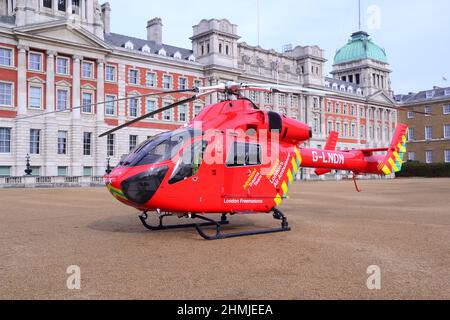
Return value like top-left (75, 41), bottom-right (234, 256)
top-left (139, 209), bottom-right (291, 240)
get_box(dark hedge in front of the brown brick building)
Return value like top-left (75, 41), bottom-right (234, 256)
top-left (396, 162), bottom-right (450, 178)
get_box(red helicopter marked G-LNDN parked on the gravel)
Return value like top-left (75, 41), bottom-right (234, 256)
top-left (96, 82), bottom-right (408, 240)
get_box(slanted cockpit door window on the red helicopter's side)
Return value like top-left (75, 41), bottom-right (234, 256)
top-left (169, 141), bottom-right (208, 184)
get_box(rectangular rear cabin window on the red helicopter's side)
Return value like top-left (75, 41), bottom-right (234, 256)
top-left (227, 142), bottom-right (262, 167)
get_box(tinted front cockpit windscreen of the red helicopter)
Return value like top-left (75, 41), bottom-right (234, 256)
top-left (120, 129), bottom-right (202, 167)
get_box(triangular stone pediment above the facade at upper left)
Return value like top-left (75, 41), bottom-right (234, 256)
top-left (14, 21), bottom-right (112, 50)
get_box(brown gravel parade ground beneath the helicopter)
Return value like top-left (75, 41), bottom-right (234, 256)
top-left (0, 179), bottom-right (450, 299)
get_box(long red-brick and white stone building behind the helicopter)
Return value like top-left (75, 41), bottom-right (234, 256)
top-left (0, 0), bottom-right (397, 177)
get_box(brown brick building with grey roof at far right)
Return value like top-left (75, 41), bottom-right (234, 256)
top-left (396, 87), bottom-right (450, 163)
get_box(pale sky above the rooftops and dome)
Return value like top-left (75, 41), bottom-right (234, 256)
top-left (109, 0), bottom-right (450, 93)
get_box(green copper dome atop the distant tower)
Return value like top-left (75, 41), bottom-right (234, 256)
top-left (334, 31), bottom-right (388, 64)
